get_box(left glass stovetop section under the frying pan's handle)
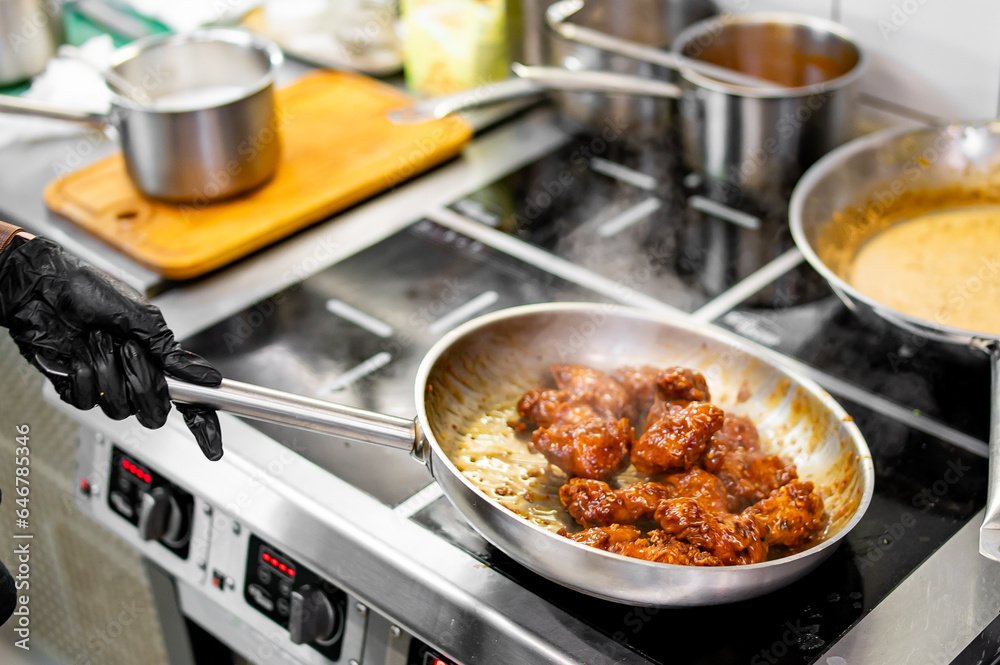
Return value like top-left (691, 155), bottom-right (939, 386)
top-left (185, 219), bottom-right (604, 506)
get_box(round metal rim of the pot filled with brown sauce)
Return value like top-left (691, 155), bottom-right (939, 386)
top-left (671, 12), bottom-right (868, 99)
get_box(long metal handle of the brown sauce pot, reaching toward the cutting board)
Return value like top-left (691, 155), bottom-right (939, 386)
top-left (389, 63), bottom-right (683, 125)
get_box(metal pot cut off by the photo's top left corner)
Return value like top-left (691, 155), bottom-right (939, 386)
top-left (0, 0), bottom-right (62, 86)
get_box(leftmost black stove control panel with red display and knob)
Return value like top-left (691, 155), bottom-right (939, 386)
top-left (108, 446), bottom-right (194, 559)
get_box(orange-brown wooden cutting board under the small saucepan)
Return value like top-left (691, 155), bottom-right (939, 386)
top-left (45, 71), bottom-right (472, 280)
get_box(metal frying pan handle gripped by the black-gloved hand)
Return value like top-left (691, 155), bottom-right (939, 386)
top-left (167, 377), bottom-right (423, 458)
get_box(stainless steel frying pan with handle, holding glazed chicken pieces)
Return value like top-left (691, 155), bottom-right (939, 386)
top-left (103, 303), bottom-right (874, 607)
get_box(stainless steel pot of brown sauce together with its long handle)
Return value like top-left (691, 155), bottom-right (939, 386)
top-left (394, 12), bottom-right (864, 210)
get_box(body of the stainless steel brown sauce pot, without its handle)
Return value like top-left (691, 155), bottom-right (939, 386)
top-left (673, 13), bottom-right (865, 207)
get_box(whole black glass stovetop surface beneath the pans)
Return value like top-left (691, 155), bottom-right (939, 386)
top-left (185, 132), bottom-right (989, 664)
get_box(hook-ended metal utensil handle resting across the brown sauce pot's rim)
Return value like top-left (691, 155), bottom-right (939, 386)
top-left (545, 0), bottom-right (781, 89)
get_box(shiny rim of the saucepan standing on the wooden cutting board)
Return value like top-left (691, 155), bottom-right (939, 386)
top-left (104, 28), bottom-right (285, 114)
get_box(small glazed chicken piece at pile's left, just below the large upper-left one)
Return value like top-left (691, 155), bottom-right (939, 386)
top-left (559, 474), bottom-right (672, 527)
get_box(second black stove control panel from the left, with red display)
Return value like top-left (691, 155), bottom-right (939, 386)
top-left (243, 534), bottom-right (347, 661)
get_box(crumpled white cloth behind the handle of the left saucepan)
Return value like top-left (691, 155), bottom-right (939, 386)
top-left (0, 35), bottom-right (115, 147)
